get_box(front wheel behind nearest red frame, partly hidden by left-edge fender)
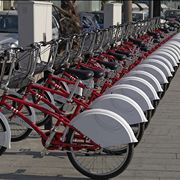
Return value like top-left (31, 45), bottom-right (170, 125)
top-left (2, 95), bottom-right (32, 142)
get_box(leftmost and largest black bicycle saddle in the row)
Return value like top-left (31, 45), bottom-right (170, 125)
top-left (65, 68), bottom-right (94, 80)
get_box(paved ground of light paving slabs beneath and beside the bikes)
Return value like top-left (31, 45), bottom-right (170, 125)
top-left (0, 66), bottom-right (180, 180)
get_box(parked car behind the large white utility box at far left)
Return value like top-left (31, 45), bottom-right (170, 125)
top-left (0, 10), bottom-right (59, 49)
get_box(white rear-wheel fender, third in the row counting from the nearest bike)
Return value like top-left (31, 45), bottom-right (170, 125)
top-left (104, 84), bottom-right (154, 112)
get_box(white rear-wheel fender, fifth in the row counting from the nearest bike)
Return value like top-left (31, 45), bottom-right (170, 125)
top-left (126, 69), bottom-right (163, 92)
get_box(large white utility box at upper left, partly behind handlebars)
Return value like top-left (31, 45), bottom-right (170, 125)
top-left (17, 1), bottom-right (52, 68)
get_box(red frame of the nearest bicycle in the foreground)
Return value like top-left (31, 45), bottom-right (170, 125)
top-left (0, 91), bottom-right (99, 150)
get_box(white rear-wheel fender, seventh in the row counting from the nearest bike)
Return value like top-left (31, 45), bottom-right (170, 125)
top-left (142, 58), bottom-right (173, 77)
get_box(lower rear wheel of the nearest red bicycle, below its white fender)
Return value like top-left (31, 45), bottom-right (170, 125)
top-left (67, 131), bottom-right (134, 179)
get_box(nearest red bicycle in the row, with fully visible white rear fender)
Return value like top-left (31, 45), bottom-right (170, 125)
top-left (0, 43), bottom-right (137, 179)
